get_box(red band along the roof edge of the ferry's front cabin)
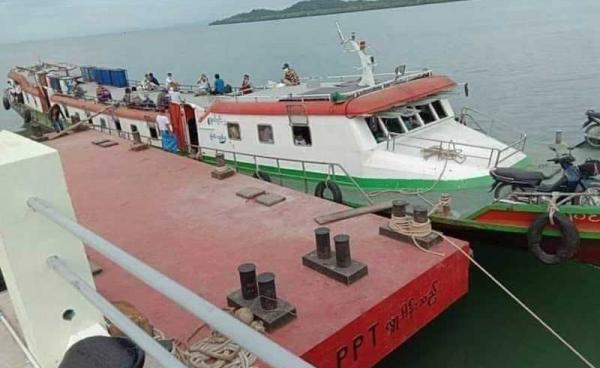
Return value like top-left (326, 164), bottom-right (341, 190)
top-left (210, 76), bottom-right (456, 116)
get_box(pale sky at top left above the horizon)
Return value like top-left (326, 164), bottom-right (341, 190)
top-left (0, 0), bottom-right (297, 43)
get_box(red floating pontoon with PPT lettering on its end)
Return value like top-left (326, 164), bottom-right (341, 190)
top-left (48, 131), bottom-right (468, 368)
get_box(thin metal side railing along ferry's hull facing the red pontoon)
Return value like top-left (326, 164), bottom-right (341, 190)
top-left (188, 144), bottom-right (373, 204)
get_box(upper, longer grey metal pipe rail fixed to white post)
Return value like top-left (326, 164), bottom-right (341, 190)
top-left (27, 198), bottom-right (314, 368)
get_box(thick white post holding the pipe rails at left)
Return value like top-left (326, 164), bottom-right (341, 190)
top-left (0, 131), bottom-right (102, 368)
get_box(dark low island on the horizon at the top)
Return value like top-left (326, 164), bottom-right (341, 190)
top-left (210, 0), bottom-right (463, 26)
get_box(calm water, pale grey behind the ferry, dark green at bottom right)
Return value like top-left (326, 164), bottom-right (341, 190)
top-left (0, 0), bottom-right (600, 368)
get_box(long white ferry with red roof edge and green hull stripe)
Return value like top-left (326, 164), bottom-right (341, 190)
top-left (4, 28), bottom-right (528, 205)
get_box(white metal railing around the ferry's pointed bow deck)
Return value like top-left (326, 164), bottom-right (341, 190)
top-left (386, 133), bottom-right (527, 168)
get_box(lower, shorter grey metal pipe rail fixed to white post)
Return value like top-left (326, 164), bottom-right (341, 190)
top-left (46, 256), bottom-right (186, 368)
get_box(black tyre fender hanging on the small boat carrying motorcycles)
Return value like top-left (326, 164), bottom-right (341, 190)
top-left (527, 213), bottom-right (580, 264)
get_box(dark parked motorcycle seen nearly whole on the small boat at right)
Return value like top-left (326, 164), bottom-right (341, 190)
top-left (490, 147), bottom-right (600, 204)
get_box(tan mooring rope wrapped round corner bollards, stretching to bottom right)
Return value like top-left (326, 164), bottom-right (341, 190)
top-left (389, 216), bottom-right (596, 368)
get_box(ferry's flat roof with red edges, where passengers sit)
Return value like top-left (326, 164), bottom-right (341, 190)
top-left (9, 63), bottom-right (456, 120)
